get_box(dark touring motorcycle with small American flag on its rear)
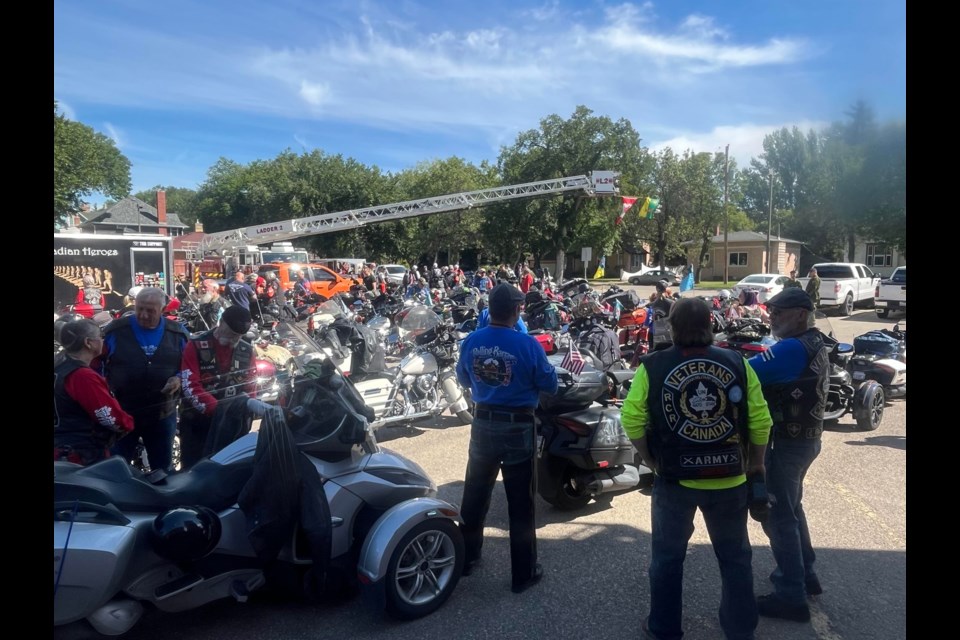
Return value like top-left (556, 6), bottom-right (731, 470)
top-left (536, 355), bottom-right (653, 510)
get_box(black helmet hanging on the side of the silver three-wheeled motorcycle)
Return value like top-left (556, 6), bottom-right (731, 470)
top-left (151, 506), bottom-right (221, 562)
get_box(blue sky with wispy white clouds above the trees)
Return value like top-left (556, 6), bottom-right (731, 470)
top-left (54, 0), bottom-right (906, 200)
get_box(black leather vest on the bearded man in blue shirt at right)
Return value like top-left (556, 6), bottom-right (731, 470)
top-left (763, 329), bottom-right (830, 441)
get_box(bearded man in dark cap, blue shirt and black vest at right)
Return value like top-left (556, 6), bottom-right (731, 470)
top-left (749, 288), bottom-right (830, 622)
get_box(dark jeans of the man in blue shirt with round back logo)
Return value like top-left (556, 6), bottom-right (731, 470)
top-left (461, 418), bottom-right (537, 586)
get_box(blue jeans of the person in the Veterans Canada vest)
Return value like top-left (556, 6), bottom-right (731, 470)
top-left (647, 476), bottom-right (758, 640)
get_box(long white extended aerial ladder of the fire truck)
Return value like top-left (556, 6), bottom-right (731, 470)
top-left (200, 171), bottom-right (620, 255)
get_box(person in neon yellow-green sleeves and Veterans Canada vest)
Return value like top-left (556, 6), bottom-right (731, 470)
top-left (621, 298), bottom-right (772, 640)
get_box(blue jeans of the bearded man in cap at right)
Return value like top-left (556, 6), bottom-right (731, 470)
top-left (763, 438), bottom-right (820, 605)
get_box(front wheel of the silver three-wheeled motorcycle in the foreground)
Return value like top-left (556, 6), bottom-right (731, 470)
top-left (384, 518), bottom-right (464, 620)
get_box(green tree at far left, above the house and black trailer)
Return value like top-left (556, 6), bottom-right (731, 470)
top-left (53, 101), bottom-right (130, 225)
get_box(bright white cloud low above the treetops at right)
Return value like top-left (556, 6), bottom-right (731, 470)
top-left (649, 120), bottom-right (829, 169)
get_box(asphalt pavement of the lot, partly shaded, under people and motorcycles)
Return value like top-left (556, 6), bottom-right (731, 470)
top-left (54, 298), bottom-right (907, 640)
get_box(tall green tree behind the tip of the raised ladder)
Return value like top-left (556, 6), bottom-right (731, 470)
top-left (496, 105), bottom-right (644, 278)
